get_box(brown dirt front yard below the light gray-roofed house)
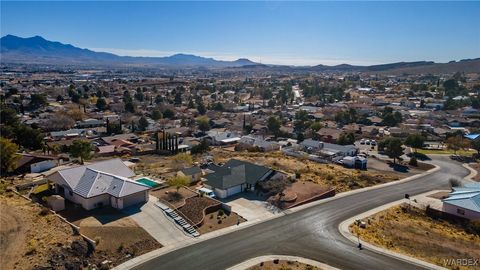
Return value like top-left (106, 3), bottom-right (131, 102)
top-left (60, 204), bottom-right (162, 265)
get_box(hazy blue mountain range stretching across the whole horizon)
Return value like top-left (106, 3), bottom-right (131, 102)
top-left (0, 35), bottom-right (480, 73)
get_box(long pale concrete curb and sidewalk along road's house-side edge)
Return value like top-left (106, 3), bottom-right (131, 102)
top-left (113, 165), bottom-right (440, 270)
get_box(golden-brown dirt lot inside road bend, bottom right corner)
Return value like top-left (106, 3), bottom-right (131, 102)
top-left (350, 206), bottom-right (480, 269)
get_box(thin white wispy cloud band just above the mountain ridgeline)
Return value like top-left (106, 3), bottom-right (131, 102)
top-left (89, 48), bottom-right (378, 66)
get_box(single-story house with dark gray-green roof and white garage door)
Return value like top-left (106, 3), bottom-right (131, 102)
top-left (205, 159), bottom-right (275, 199)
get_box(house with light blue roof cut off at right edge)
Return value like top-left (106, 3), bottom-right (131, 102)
top-left (443, 183), bottom-right (480, 220)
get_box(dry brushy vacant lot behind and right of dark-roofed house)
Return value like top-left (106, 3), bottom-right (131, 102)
top-left (211, 148), bottom-right (403, 193)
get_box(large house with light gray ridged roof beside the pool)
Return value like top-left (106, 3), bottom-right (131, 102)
top-left (47, 159), bottom-right (150, 210)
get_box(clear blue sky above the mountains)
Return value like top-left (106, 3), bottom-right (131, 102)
top-left (0, 0), bottom-right (480, 65)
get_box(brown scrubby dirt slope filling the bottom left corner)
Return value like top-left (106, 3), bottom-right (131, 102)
top-left (0, 192), bottom-right (89, 269)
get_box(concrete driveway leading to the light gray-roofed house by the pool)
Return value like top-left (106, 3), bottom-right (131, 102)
top-left (124, 196), bottom-right (193, 246)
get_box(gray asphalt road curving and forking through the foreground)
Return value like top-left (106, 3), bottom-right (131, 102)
top-left (134, 157), bottom-right (469, 270)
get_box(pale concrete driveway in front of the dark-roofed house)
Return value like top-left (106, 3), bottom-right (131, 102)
top-left (224, 193), bottom-right (282, 222)
